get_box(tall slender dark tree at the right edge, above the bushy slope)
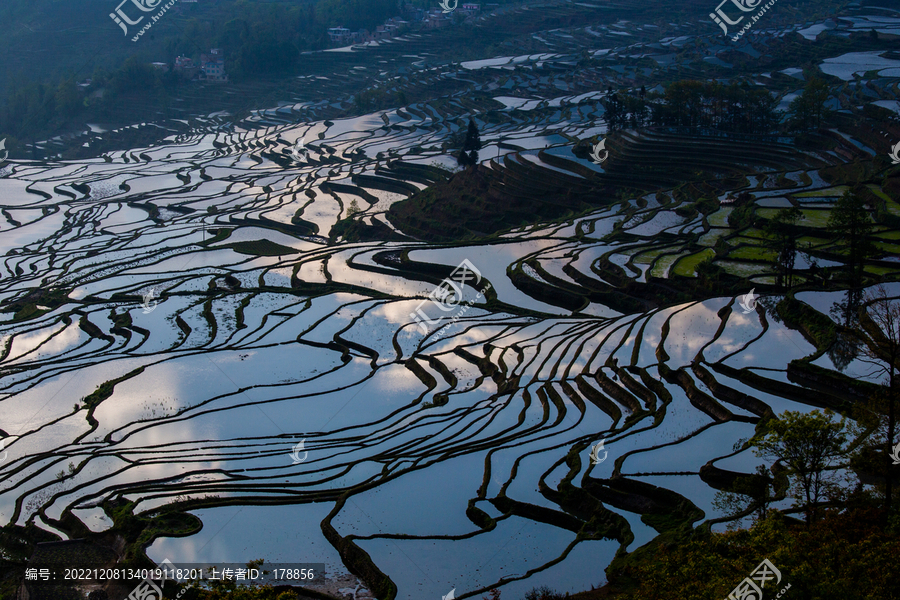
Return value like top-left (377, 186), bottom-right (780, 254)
top-left (859, 285), bottom-right (900, 513)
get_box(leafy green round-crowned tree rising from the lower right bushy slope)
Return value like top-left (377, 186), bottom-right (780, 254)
top-left (750, 409), bottom-right (847, 526)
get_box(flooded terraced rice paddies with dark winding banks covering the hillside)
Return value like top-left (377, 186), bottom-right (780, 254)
top-left (0, 0), bottom-right (900, 598)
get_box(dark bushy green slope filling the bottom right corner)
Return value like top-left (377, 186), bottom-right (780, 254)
top-left (596, 510), bottom-right (900, 600)
